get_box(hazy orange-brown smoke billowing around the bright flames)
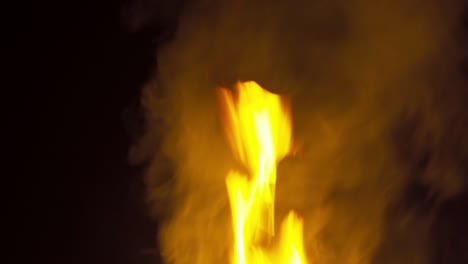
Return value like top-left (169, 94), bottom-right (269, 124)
top-left (126, 0), bottom-right (468, 264)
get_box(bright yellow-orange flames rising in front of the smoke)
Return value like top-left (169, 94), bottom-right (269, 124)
top-left (220, 82), bottom-right (307, 264)
